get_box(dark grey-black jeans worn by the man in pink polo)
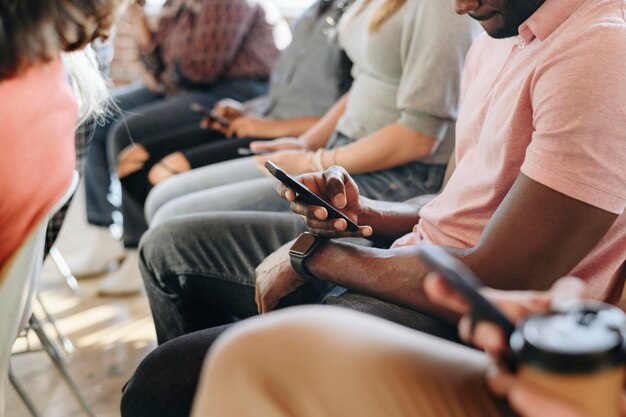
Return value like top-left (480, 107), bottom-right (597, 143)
top-left (122, 212), bottom-right (457, 417)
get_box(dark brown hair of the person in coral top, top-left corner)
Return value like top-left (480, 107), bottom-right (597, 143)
top-left (0, 0), bottom-right (125, 80)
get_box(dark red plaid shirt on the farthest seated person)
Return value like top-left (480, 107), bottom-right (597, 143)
top-left (140, 0), bottom-right (279, 86)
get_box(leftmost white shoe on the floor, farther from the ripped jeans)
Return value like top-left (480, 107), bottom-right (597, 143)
top-left (65, 226), bottom-right (126, 277)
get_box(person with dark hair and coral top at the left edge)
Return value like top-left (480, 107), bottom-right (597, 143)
top-left (0, 0), bottom-right (122, 268)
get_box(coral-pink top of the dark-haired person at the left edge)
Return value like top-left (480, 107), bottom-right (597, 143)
top-left (0, 59), bottom-right (78, 268)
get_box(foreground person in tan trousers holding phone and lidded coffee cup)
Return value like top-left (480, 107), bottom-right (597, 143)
top-left (192, 276), bottom-right (612, 417)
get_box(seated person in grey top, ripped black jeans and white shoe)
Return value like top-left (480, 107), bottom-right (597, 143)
top-left (84, 0), bottom-right (352, 295)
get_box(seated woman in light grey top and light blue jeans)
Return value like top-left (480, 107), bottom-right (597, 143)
top-left (146, 0), bottom-right (480, 224)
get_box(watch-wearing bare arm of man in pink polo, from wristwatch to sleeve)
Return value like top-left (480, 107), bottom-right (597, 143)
top-left (307, 175), bottom-right (617, 322)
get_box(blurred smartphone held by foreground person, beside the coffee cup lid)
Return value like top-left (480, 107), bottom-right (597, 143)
top-left (418, 244), bottom-right (515, 340)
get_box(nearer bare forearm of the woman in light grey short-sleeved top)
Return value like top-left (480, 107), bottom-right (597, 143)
top-left (333, 123), bottom-right (437, 174)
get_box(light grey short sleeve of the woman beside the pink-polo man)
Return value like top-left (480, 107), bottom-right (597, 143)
top-left (397, 0), bottom-right (482, 141)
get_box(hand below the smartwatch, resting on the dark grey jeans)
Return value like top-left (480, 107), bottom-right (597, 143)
top-left (255, 241), bottom-right (307, 314)
